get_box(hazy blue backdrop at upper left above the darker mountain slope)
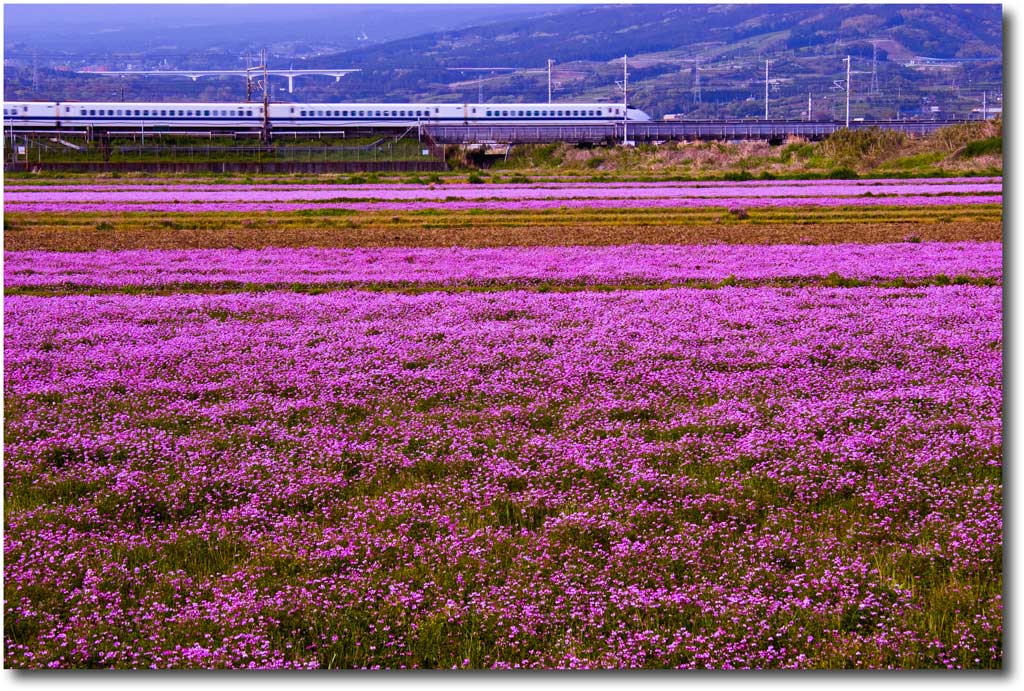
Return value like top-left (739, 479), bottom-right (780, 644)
top-left (4, 4), bottom-right (573, 59)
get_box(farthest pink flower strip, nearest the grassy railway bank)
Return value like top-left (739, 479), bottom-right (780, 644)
top-left (4, 178), bottom-right (1002, 212)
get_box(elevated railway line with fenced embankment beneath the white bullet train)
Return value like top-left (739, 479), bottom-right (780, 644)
top-left (4, 120), bottom-right (964, 172)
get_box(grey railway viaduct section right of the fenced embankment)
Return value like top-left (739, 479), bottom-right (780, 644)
top-left (424, 120), bottom-right (965, 144)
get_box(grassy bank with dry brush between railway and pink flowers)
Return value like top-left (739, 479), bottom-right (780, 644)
top-left (4, 120), bottom-right (1002, 184)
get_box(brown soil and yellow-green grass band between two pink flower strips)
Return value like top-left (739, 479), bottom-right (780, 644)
top-left (4, 207), bottom-right (1002, 252)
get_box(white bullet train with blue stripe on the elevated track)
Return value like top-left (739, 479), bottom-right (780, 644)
top-left (3, 101), bottom-right (650, 130)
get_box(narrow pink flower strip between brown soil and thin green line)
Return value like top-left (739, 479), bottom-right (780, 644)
top-left (4, 243), bottom-right (1002, 288)
